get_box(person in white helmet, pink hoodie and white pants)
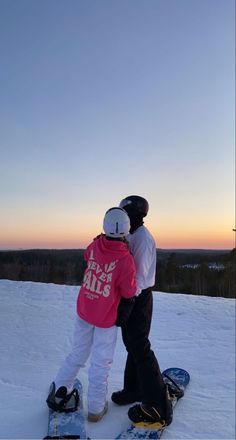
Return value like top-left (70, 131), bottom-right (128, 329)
top-left (47, 207), bottom-right (137, 422)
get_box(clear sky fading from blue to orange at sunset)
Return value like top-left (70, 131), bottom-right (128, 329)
top-left (0, 0), bottom-right (235, 249)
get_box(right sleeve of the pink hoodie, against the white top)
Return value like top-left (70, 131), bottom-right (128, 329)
top-left (119, 254), bottom-right (137, 298)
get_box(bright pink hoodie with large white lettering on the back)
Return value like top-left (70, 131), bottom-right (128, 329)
top-left (77, 235), bottom-right (137, 328)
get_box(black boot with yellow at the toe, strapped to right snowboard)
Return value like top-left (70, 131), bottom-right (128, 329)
top-left (128, 388), bottom-right (173, 429)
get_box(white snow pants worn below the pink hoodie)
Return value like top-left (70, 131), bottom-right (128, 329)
top-left (55, 316), bottom-right (117, 414)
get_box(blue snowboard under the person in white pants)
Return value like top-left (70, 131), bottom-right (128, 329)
top-left (44, 379), bottom-right (87, 439)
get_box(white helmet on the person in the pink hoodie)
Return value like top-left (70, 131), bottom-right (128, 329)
top-left (103, 208), bottom-right (130, 238)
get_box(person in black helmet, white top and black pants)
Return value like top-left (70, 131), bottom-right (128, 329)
top-left (111, 195), bottom-right (177, 426)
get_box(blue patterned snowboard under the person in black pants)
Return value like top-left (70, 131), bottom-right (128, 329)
top-left (116, 368), bottom-right (190, 440)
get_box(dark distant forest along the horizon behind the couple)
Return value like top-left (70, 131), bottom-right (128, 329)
top-left (0, 248), bottom-right (236, 298)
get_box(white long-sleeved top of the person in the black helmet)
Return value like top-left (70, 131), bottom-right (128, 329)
top-left (127, 226), bottom-right (156, 295)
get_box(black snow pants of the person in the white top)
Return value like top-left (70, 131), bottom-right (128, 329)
top-left (122, 288), bottom-right (165, 406)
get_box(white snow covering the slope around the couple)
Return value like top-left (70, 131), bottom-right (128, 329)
top-left (0, 280), bottom-right (235, 440)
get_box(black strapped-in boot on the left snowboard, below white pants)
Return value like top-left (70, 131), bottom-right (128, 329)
top-left (46, 382), bottom-right (79, 412)
